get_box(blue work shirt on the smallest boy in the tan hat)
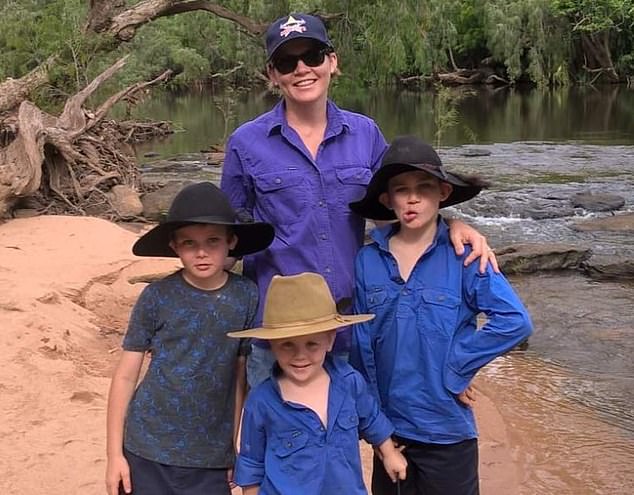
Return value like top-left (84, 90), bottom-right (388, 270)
top-left (235, 356), bottom-right (394, 495)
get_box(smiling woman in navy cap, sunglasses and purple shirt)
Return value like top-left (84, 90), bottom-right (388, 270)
top-left (221, 14), bottom-right (497, 386)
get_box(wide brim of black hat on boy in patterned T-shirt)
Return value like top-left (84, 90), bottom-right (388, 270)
top-left (132, 217), bottom-right (275, 258)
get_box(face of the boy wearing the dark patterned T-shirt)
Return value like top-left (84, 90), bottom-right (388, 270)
top-left (170, 224), bottom-right (238, 289)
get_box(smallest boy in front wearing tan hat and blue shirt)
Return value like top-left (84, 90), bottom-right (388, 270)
top-left (228, 273), bottom-right (407, 495)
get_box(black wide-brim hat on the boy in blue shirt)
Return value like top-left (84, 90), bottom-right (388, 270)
top-left (348, 136), bottom-right (488, 220)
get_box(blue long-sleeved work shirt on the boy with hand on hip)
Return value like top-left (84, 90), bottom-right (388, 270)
top-left (350, 221), bottom-right (532, 444)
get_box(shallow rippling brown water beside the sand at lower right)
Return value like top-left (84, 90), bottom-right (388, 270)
top-left (482, 275), bottom-right (634, 495)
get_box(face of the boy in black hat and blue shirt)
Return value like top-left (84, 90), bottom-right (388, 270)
top-left (379, 170), bottom-right (452, 229)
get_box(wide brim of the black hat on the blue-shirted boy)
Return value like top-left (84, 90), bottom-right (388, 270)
top-left (348, 163), bottom-right (484, 220)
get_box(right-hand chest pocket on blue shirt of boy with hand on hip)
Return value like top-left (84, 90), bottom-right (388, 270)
top-left (419, 288), bottom-right (461, 340)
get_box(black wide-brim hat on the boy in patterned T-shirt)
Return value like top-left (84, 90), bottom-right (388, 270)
top-left (132, 182), bottom-right (275, 258)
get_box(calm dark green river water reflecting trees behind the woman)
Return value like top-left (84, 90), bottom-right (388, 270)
top-left (127, 85), bottom-right (634, 161)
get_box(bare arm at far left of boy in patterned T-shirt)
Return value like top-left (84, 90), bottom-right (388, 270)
top-left (106, 351), bottom-right (144, 495)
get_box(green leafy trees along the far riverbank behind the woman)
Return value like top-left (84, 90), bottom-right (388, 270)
top-left (0, 0), bottom-right (634, 103)
